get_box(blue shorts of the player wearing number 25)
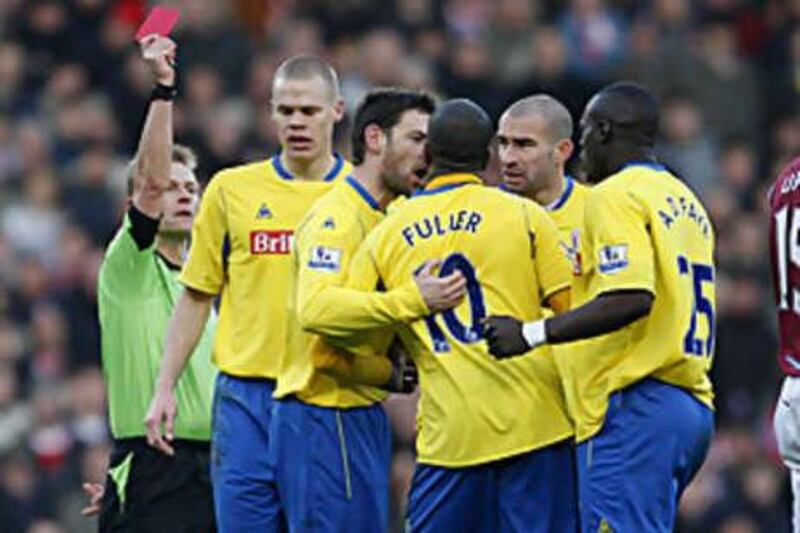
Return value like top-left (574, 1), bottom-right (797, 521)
top-left (578, 379), bottom-right (714, 533)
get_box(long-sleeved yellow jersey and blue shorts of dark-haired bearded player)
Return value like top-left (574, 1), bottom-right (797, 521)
top-left (271, 176), bottom-right (427, 531)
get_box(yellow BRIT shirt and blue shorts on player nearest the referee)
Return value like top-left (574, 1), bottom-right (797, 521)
top-left (180, 156), bottom-right (351, 530)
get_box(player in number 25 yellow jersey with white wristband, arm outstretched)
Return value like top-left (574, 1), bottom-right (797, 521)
top-left (485, 83), bottom-right (714, 532)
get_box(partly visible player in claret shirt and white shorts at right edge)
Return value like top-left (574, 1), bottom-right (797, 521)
top-left (769, 158), bottom-right (800, 532)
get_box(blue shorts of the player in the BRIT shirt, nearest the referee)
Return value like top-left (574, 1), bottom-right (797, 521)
top-left (211, 372), bottom-right (285, 533)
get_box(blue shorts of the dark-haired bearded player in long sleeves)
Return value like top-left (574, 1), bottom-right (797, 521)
top-left (270, 397), bottom-right (392, 533)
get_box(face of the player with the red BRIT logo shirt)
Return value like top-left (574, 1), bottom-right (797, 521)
top-left (272, 76), bottom-right (344, 161)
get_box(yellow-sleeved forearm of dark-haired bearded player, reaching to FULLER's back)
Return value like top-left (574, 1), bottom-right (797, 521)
top-left (299, 283), bottom-right (428, 337)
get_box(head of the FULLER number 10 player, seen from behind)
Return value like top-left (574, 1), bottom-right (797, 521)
top-left (428, 98), bottom-right (494, 172)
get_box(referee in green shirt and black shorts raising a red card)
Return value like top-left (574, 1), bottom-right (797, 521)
top-left (97, 35), bottom-right (216, 532)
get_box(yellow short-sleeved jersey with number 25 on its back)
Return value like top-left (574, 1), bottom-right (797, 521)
top-left (565, 163), bottom-right (715, 442)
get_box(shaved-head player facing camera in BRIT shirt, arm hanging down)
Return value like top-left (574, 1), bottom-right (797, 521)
top-left (144, 56), bottom-right (350, 532)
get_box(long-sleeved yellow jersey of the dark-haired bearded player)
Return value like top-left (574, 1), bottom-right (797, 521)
top-left (275, 176), bottom-right (427, 408)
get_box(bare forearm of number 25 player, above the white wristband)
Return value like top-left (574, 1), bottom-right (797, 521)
top-left (544, 291), bottom-right (653, 344)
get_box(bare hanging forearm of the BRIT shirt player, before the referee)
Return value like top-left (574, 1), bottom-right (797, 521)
top-left (157, 289), bottom-right (212, 389)
